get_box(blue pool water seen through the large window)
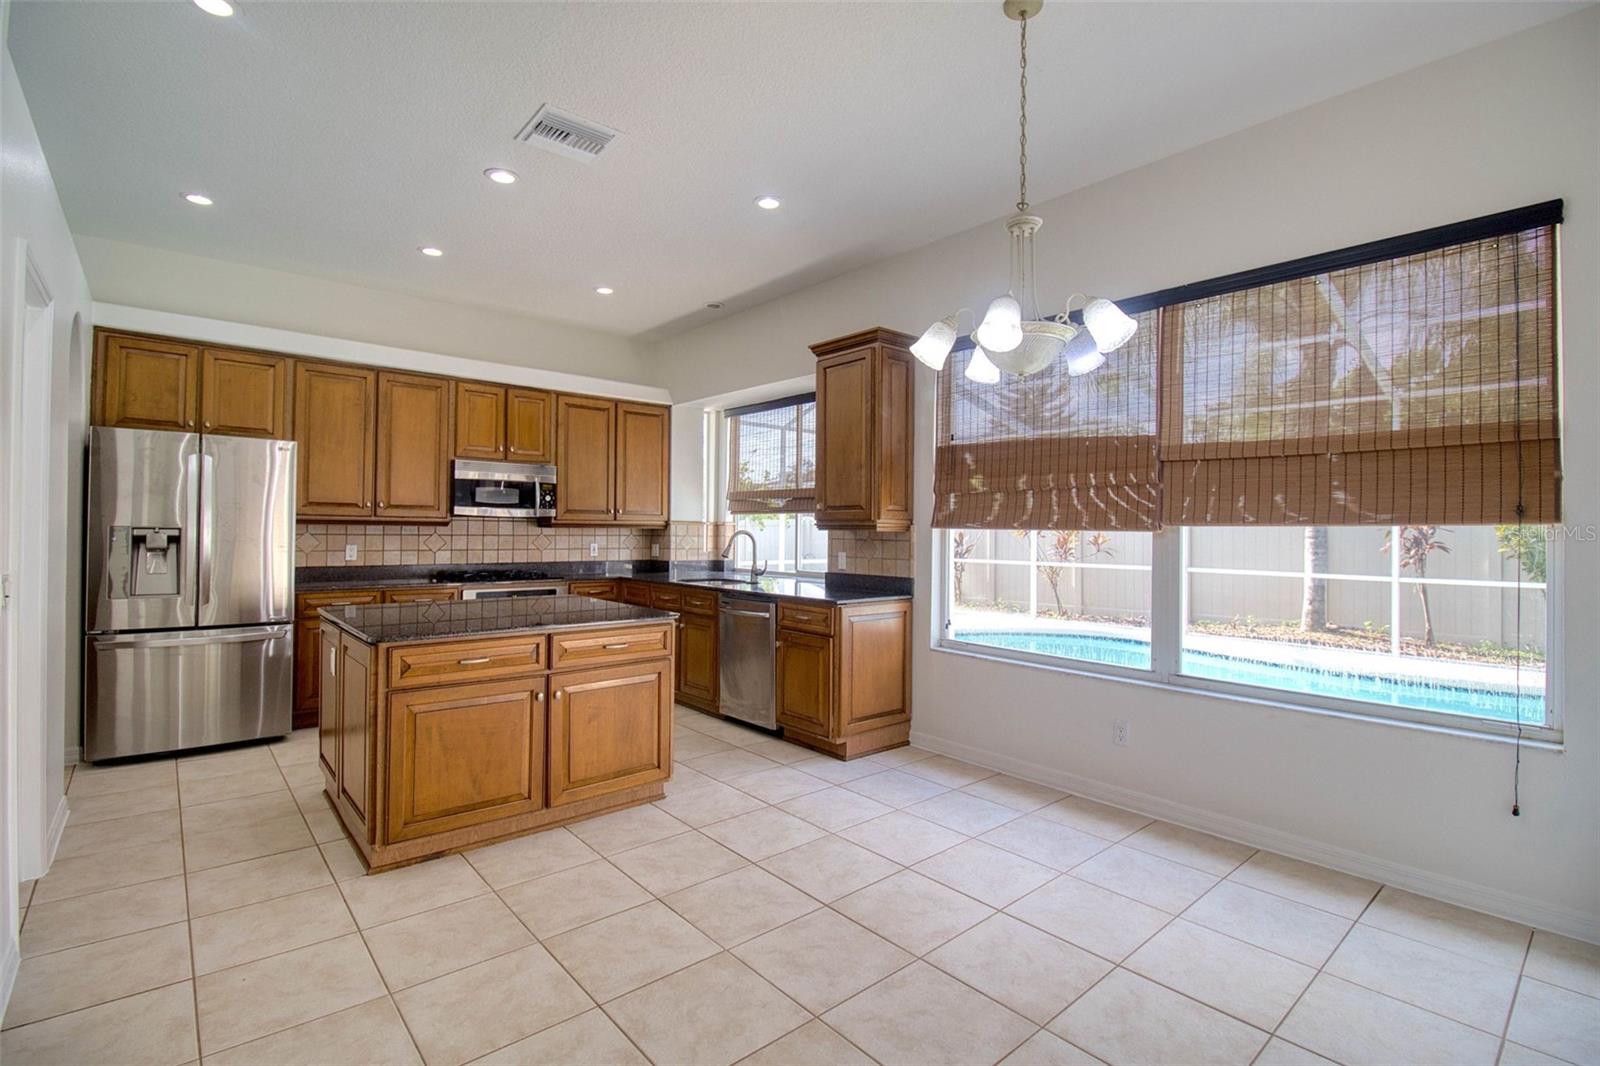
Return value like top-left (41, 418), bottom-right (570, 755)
top-left (955, 631), bottom-right (1544, 725)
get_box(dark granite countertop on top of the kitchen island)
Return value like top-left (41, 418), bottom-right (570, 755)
top-left (318, 595), bottom-right (677, 643)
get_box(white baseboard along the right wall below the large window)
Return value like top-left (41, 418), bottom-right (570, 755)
top-left (910, 723), bottom-right (1600, 943)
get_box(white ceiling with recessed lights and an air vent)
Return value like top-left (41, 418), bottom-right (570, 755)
top-left (10, 0), bottom-right (1581, 338)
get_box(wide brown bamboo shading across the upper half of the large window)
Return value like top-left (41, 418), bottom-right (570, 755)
top-left (933, 200), bottom-right (1562, 530)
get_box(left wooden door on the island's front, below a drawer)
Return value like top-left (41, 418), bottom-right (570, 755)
top-left (387, 677), bottom-right (546, 840)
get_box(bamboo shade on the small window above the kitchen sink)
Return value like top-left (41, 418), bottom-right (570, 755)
top-left (728, 395), bottom-right (816, 514)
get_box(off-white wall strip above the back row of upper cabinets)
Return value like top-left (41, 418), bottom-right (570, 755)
top-left (77, 234), bottom-right (659, 392)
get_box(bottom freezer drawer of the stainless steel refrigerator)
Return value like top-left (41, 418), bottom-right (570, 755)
top-left (83, 626), bottom-right (294, 762)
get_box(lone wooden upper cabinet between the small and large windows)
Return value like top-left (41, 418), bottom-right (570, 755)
top-left (811, 327), bottom-right (915, 533)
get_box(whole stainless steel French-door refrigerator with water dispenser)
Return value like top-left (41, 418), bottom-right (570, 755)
top-left (83, 427), bottom-right (294, 762)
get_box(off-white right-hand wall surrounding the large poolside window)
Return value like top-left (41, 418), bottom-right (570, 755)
top-left (661, 8), bottom-right (1600, 940)
